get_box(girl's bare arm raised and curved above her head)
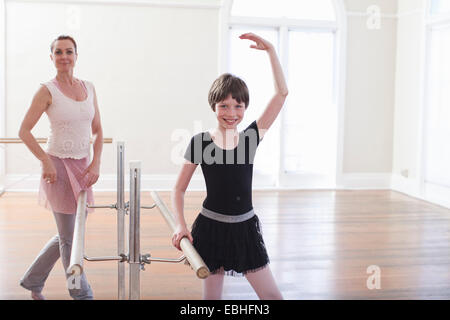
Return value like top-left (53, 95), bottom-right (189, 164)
top-left (239, 33), bottom-right (288, 139)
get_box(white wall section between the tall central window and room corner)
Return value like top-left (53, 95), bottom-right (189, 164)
top-left (344, 1), bottom-right (396, 173)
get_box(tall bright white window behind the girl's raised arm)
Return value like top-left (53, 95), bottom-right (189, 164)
top-left (224, 0), bottom-right (338, 187)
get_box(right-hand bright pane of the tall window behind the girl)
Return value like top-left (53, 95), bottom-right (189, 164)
top-left (283, 31), bottom-right (337, 174)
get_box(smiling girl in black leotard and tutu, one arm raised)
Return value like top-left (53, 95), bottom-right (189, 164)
top-left (172, 33), bottom-right (288, 299)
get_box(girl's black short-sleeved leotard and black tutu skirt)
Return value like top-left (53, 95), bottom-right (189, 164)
top-left (184, 121), bottom-right (269, 276)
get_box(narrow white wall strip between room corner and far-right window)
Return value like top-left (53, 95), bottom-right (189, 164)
top-left (392, 0), bottom-right (426, 195)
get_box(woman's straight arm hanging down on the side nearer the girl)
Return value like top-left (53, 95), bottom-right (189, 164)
top-left (85, 88), bottom-right (103, 187)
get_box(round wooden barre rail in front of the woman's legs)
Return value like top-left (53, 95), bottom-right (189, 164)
top-left (66, 190), bottom-right (87, 276)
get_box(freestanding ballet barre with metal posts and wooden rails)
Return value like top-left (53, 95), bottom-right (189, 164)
top-left (67, 141), bottom-right (209, 300)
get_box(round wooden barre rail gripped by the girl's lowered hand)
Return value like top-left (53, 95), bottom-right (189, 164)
top-left (150, 191), bottom-right (209, 279)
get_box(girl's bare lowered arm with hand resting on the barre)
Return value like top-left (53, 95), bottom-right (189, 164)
top-left (172, 160), bottom-right (197, 250)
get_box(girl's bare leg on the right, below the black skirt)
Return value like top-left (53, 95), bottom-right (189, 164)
top-left (245, 266), bottom-right (283, 300)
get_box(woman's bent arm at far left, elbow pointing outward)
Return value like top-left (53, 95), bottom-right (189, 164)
top-left (19, 86), bottom-right (56, 183)
